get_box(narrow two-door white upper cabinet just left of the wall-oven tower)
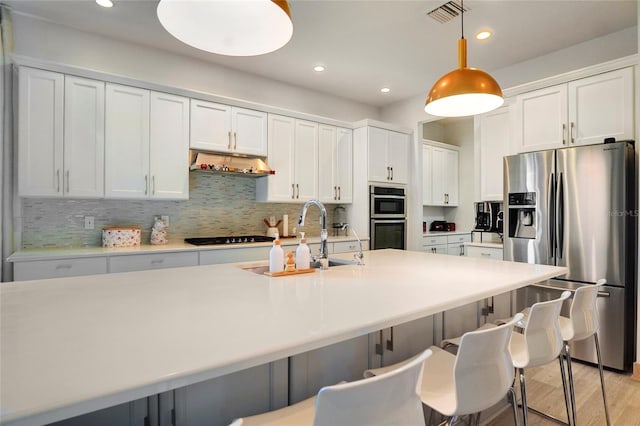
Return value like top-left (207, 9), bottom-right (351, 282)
top-left (318, 124), bottom-right (353, 203)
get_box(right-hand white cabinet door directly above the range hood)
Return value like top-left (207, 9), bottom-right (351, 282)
top-left (231, 107), bottom-right (267, 157)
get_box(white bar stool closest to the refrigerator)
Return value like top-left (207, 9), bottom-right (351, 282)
top-left (558, 279), bottom-right (611, 426)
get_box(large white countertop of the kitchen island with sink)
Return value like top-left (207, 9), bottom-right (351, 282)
top-left (0, 250), bottom-right (567, 425)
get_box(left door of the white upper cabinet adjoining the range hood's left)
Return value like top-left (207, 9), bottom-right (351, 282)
top-left (105, 84), bottom-right (149, 199)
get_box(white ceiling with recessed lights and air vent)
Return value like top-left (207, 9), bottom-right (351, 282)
top-left (4, 0), bottom-right (638, 106)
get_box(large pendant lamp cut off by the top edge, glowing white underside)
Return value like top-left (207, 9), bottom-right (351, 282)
top-left (157, 0), bottom-right (293, 56)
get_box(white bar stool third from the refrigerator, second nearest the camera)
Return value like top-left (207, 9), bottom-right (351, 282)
top-left (364, 314), bottom-right (522, 425)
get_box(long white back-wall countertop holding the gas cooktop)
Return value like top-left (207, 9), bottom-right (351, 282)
top-left (7, 236), bottom-right (369, 262)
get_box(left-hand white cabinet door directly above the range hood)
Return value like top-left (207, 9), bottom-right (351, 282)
top-left (189, 99), bottom-right (233, 152)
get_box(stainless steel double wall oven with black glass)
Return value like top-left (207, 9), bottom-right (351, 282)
top-left (369, 185), bottom-right (407, 250)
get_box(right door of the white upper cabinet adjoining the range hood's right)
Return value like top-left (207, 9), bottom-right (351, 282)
top-left (293, 120), bottom-right (318, 201)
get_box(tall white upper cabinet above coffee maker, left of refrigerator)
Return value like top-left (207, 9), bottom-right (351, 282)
top-left (474, 106), bottom-right (513, 201)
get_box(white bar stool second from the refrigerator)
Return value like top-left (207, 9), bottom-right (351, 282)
top-left (509, 291), bottom-right (571, 426)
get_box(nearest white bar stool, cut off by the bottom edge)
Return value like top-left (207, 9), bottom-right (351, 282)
top-left (231, 349), bottom-right (431, 426)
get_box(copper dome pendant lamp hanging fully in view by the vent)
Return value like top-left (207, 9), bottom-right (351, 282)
top-left (424, 2), bottom-right (504, 117)
